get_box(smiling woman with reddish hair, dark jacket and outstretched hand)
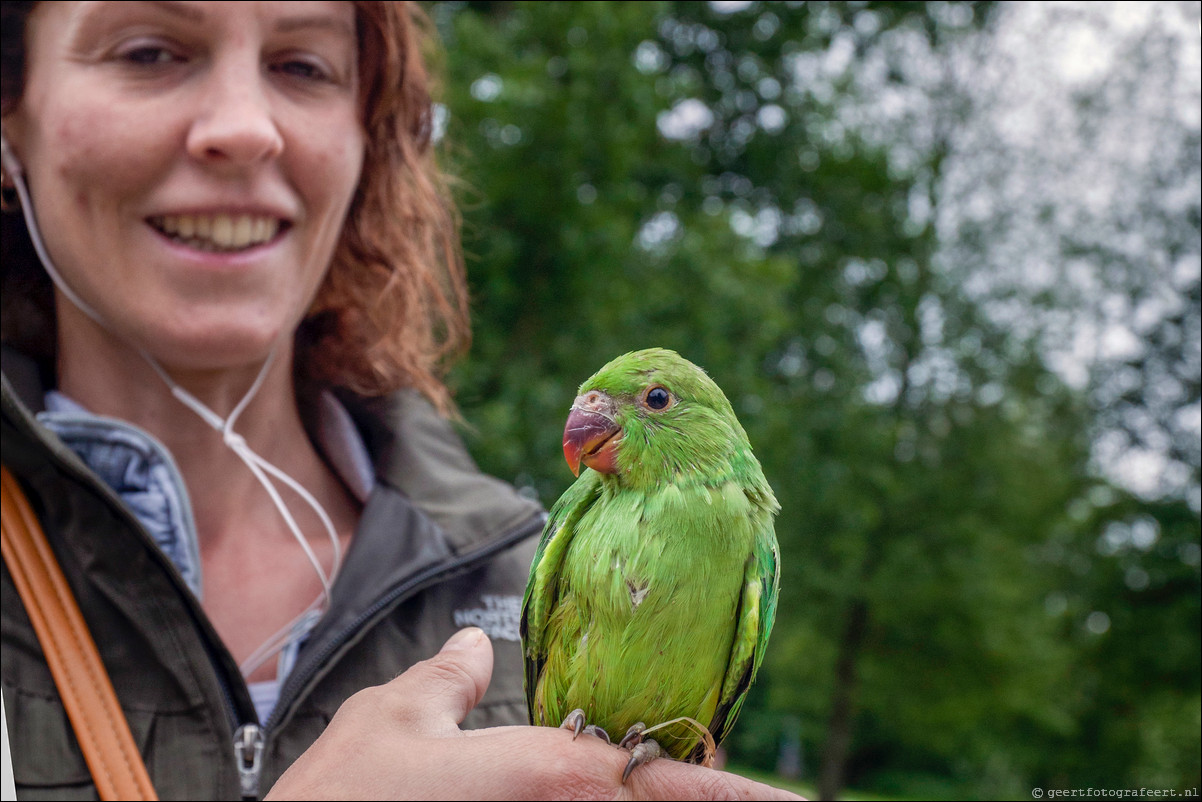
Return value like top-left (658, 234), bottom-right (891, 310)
top-left (2, 2), bottom-right (802, 798)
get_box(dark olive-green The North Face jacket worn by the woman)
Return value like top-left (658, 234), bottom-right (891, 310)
top-left (0, 349), bottom-right (543, 800)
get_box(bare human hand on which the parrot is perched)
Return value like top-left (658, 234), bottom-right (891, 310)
top-left (264, 628), bottom-right (802, 800)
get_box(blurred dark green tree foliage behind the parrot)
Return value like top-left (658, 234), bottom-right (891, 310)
top-left (430, 2), bottom-right (1202, 798)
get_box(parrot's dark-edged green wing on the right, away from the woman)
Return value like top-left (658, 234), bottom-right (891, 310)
top-left (709, 516), bottom-right (780, 743)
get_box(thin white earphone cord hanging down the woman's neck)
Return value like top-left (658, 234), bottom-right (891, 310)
top-left (0, 131), bottom-right (343, 677)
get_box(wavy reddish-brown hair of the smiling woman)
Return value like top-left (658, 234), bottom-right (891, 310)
top-left (0, 0), bottom-right (470, 414)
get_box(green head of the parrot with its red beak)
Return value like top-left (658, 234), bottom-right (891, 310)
top-left (564, 349), bottom-right (754, 485)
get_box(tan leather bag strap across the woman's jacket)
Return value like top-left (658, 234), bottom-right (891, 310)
top-left (0, 468), bottom-right (157, 800)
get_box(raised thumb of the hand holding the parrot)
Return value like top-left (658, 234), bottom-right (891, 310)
top-left (386, 626), bottom-right (493, 736)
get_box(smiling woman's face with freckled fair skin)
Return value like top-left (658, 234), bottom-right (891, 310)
top-left (4, 2), bottom-right (365, 370)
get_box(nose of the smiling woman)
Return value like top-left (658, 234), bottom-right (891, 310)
top-left (188, 60), bottom-right (284, 168)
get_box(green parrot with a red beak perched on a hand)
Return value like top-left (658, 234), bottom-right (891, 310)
top-left (520, 349), bottom-right (780, 782)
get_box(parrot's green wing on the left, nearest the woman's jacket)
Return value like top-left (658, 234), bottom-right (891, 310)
top-left (519, 470), bottom-right (601, 726)
